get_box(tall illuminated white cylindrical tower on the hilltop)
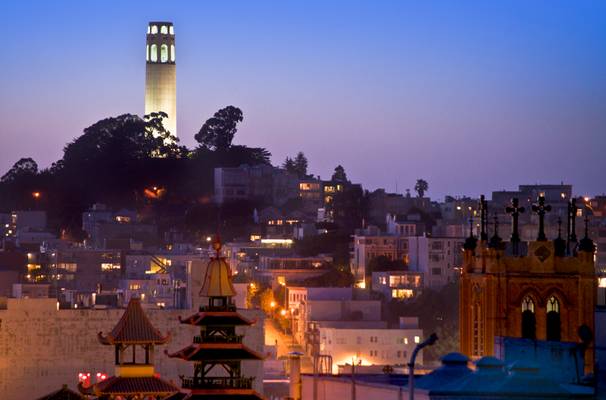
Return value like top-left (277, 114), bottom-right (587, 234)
top-left (145, 22), bottom-right (177, 136)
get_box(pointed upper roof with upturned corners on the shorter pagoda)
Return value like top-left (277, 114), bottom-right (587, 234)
top-left (98, 298), bottom-right (170, 344)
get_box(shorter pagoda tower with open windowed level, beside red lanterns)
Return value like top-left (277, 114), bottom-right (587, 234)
top-left (78, 298), bottom-right (179, 400)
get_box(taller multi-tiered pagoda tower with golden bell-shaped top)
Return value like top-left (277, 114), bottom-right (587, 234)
top-left (167, 239), bottom-right (263, 400)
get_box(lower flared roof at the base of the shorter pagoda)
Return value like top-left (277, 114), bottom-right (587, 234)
top-left (78, 376), bottom-right (179, 396)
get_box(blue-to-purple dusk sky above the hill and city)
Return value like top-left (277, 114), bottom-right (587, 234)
top-left (0, 0), bottom-right (606, 198)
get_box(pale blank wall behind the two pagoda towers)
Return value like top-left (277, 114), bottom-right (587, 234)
top-left (0, 299), bottom-right (264, 400)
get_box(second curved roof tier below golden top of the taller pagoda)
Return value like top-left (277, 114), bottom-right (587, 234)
top-left (165, 343), bottom-right (265, 361)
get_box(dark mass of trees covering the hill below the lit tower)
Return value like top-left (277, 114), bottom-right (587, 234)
top-left (0, 106), bottom-right (271, 236)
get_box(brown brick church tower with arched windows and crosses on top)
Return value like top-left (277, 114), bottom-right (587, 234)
top-left (459, 196), bottom-right (597, 372)
